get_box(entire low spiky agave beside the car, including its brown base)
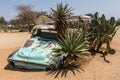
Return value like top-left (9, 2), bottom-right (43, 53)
top-left (54, 30), bottom-right (88, 64)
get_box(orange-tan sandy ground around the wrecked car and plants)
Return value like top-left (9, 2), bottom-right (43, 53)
top-left (0, 30), bottom-right (120, 80)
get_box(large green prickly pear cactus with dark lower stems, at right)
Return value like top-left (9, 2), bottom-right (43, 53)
top-left (89, 13), bottom-right (119, 62)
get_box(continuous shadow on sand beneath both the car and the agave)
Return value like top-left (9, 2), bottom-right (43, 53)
top-left (4, 58), bottom-right (91, 78)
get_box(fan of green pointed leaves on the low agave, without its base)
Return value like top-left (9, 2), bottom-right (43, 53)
top-left (53, 30), bottom-right (88, 59)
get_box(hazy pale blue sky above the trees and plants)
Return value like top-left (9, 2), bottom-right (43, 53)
top-left (0, 0), bottom-right (120, 21)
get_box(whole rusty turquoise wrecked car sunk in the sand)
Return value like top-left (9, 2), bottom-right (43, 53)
top-left (8, 25), bottom-right (63, 70)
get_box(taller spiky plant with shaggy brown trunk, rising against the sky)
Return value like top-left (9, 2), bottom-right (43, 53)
top-left (51, 3), bottom-right (73, 34)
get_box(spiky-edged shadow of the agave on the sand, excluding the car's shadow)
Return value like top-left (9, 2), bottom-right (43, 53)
top-left (47, 56), bottom-right (93, 78)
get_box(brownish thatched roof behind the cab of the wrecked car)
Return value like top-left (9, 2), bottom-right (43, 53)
top-left (35, 16), bottom-right (54, 25)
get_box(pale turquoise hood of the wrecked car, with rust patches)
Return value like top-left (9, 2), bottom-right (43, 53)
top-left (11, 38), bottom-right (59, 65)
